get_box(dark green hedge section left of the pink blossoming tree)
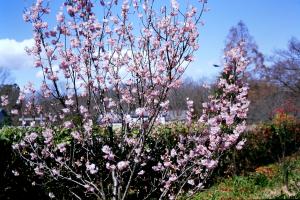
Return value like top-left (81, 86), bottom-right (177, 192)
top-left (0, 127), bottom-right (48, 200)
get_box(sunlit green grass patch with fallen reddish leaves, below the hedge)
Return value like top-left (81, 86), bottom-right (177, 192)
top-left (190, 153), bottom-right (300, 200)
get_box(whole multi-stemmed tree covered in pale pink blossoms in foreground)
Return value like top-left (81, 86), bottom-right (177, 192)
top-left (13, 0), bottom-right (249, 200)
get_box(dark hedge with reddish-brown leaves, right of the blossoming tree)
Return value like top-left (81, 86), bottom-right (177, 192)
top-left (216, 112), bottom-right (300, 176)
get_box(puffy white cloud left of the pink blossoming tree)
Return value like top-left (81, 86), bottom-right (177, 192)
top-left (0, 39), bottom-right (34, 70)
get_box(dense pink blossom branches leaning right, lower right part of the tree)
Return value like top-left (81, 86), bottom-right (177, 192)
top-left (153, 43), bottom-right (250, 199)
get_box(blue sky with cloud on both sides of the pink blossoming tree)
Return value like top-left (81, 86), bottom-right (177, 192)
top-left (0, 0), bottom-right (300, 86)
